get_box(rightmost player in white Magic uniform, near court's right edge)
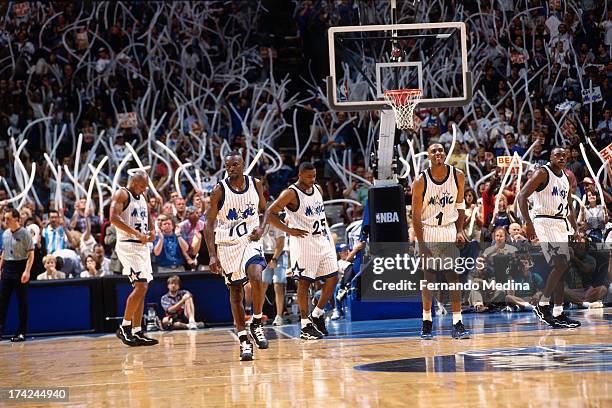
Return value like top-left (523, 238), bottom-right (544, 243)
top-left (517, 147), bottom-right (580, 327)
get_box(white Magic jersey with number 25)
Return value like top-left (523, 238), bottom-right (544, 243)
top-left (286, 184), bottom-right (327, 238)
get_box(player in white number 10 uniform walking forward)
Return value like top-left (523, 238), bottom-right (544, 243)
top-left (204, 151), bottom-right (268, 361)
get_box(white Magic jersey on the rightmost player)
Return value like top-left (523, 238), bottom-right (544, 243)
top-left (532, 164), bottom-right (570, 218)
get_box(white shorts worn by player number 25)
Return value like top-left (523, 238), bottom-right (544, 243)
top-left (289, 236), bottom-right (338, 282)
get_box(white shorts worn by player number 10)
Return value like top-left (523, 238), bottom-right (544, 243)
top-left (217, 237), bottom-right (267, 286)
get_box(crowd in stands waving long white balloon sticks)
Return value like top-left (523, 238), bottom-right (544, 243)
top-left (0, 0), bottom-right (612, 324)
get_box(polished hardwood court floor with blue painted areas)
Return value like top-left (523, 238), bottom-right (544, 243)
top-left (0, 309), bottom-right (612, 408)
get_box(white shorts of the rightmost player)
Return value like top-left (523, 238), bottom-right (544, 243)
top-left (533, 215), bottom-right (572, 263)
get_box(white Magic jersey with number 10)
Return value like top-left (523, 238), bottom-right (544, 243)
top-left (215, 176), bottom-right (259, 244)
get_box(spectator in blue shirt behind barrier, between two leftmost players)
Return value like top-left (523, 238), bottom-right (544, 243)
top-left (153, 215), bottom-right (195, 273)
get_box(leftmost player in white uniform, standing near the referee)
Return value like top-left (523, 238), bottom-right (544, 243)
top-left (110, 170), bottom-right (159, 346)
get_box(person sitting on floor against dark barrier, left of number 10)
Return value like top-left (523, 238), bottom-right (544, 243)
top-left (161, 275), bottom-right (204, 330)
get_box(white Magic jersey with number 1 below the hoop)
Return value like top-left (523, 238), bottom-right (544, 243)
top-left (421, 165), bottom-right (459, 227)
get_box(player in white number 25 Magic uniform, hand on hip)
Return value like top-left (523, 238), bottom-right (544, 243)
top-left (262, 162), bottom-right (338, 340)
